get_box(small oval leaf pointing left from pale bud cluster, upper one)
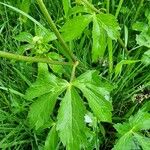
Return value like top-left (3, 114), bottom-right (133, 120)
top-left (15, 32), bottom-right (33, 43)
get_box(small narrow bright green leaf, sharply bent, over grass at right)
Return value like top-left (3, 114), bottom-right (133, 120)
top-left (115, 60), bottom-right (139, 76)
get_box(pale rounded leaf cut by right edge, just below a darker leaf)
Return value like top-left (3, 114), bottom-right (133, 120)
top-left (136, 31), bottom-right (150, 48)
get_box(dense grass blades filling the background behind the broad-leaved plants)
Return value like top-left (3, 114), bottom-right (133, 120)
top-left (0, 0), bottom-right (150, 150)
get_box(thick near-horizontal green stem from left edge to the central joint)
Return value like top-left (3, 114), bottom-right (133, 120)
top-left (0, 51), bottom-right (73, 66)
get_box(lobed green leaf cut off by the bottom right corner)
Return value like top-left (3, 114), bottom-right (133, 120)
top-left (113, 109), bottom-right (150, 150)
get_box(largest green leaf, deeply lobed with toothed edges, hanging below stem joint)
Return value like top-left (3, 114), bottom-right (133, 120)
top-left (25, 64), bottom-right (112, 150)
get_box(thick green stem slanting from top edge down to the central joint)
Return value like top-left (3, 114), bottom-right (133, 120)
top-left (37, 0), bottom-right (76, 62)
